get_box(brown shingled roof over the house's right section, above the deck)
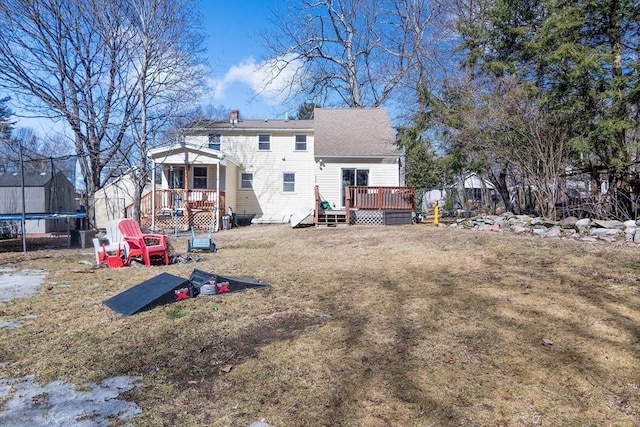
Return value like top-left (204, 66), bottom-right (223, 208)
top-left (313, 108), bottom-right (400, 157)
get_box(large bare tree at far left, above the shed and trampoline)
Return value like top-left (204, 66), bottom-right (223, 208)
top-left (0, 0), bottom-right (136, 204)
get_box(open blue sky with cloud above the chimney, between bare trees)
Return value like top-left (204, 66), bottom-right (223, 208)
top-left (200, 0), bottom-right (297, 119)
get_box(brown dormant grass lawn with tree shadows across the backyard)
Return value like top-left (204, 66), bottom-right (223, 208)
top-left (0, 225), bottom-right (640, 427)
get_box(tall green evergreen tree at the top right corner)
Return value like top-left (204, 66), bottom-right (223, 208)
top-left (460, 0), bottom-right (640, 217)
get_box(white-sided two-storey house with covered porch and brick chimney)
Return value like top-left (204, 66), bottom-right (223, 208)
top-left (141, 108), bottom-right (400, 232)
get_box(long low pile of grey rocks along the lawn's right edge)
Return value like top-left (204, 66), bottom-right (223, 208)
top-left (450, 212), bottom-right (640, 243)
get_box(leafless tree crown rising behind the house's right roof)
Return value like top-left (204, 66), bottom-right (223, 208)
top-left (262, 0), bottom-right (420, 108)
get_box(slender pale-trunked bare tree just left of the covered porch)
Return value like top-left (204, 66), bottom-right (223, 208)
top-left (124, 0), bottom-right (205, 219)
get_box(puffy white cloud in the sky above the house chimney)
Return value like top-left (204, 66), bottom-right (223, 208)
top-left (209, 53), bottom-right (302, 105)
